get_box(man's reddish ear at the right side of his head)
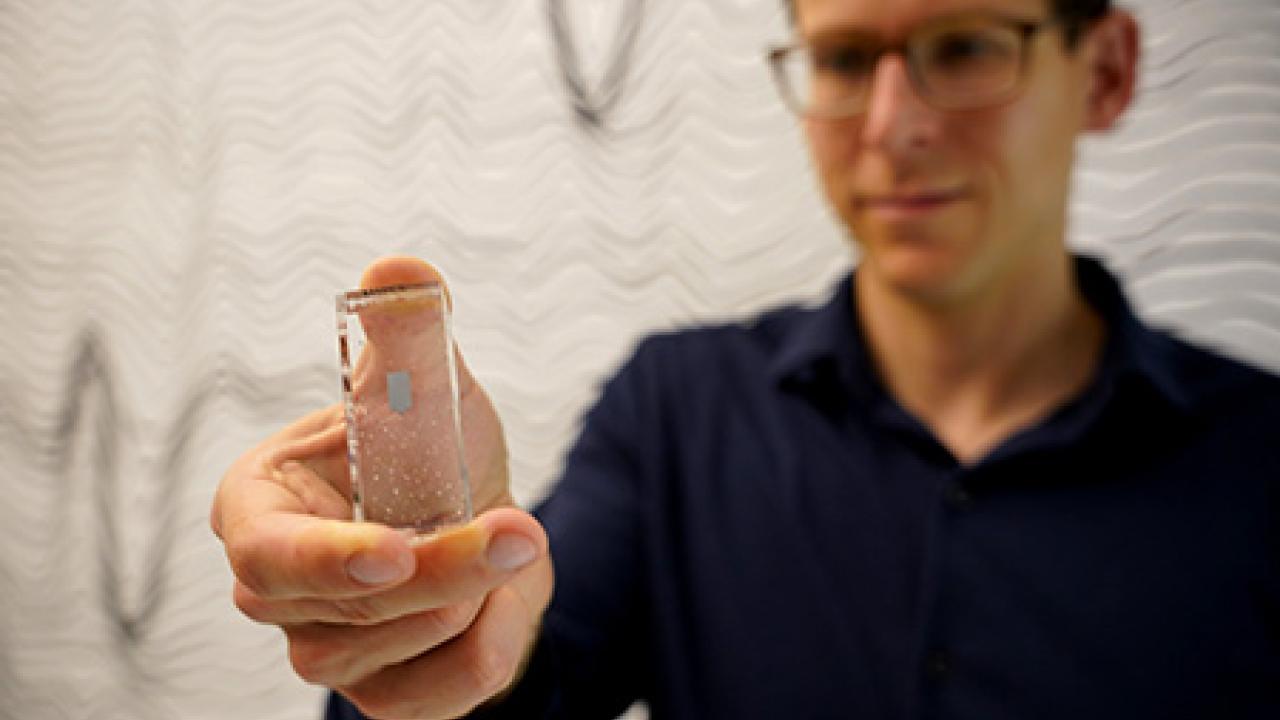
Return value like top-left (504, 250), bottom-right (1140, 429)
top-left (1079, 10), bottom-right (1142, 132)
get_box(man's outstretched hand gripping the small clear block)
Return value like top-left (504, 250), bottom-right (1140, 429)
top-left (211, 258), bottom-right (553, 719)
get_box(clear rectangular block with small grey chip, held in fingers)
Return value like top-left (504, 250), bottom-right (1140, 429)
top-left (338, 284), bottom-right (471, 533)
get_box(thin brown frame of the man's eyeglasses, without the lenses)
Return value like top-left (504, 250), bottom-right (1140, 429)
top-left (765, 13), bottom-right (1070, 120)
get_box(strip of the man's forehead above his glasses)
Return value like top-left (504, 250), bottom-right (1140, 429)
top-left (792, 0), bottom-right (1050, 36)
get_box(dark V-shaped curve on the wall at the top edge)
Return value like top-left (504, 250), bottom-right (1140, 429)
top-left (547, 0), bottom-right (645, 129)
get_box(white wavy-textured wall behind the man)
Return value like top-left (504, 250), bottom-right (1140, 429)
top-left (0, 0), bottom-right (1280, 720)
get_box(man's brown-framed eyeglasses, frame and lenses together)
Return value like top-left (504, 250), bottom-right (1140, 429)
top-left (768, 14), bottom-right (1059, 119)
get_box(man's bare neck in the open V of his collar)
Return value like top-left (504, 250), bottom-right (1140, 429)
top-left (855, 252), bottom-right (1103, 462)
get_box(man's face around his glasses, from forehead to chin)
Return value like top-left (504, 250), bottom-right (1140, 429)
top-left (795, 0), bottom-right (1088, 302)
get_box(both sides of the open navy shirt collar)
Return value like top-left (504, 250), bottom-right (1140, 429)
top-left (769, 255), bottom-right (1190, 410)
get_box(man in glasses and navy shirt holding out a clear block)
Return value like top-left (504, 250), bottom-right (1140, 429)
top-left (212, 0), bottom-right (1280, 719)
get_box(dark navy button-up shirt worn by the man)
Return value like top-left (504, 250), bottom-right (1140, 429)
top-left (328, 259), bottom-right (1280, 720)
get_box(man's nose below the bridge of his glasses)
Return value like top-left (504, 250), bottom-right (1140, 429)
top-left (861, 53), bottom-right (940, 155)
